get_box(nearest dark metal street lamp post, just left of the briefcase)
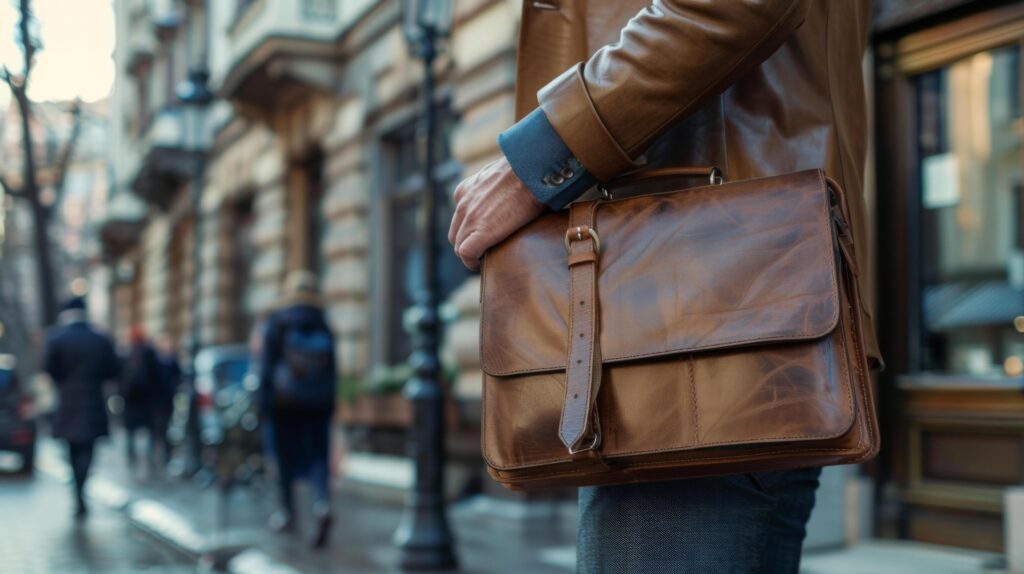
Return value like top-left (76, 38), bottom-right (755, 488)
top-left (394, 0), bottom-right (457, 570)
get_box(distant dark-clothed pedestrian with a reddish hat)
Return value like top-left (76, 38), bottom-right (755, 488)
top-left (121, 325), bottom-right (162, 472)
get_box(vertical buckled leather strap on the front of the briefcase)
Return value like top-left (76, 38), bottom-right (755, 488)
top-left (558, 202), bottom-right (601, 455)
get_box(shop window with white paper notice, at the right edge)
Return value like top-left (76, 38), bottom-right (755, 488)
top-left (914, 46), bottom-right (1024, 377)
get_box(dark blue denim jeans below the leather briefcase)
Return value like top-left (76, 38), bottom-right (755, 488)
top-left (577, 469), bottom-right (821, 574)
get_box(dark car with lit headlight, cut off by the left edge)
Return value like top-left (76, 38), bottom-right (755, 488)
top-left (0, 355), bottom-right (37, 475)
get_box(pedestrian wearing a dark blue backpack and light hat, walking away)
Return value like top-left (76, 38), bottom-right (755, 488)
top-left (259, 271), bottom-right (337, 548)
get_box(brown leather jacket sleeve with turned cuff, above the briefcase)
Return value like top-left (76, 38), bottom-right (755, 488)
top-left (538, 0), bottom-right (810, 181)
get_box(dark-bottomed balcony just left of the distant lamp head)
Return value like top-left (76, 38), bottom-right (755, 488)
top-left (132, 107), bottom-right (197, 210)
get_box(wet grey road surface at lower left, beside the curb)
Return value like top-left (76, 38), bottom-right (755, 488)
top-left (0, 474), bottom-right (196, 574)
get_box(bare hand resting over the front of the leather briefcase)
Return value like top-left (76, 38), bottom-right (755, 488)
top-left (449, 158), bottom-right (544, 270)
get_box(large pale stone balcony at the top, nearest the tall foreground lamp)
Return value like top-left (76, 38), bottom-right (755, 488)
top-left (212, 0), bottom-right (379, 112)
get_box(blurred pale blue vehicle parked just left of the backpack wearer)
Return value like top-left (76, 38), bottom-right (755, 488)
top-left (169, 345), bottom-right (263, 482)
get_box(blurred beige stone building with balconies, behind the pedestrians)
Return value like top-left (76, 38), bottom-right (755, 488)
top-left (101, 0), bottom-right (512, 478)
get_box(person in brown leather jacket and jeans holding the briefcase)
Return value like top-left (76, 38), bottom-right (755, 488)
top-left (449, 0), bottom-right (879, 573)
